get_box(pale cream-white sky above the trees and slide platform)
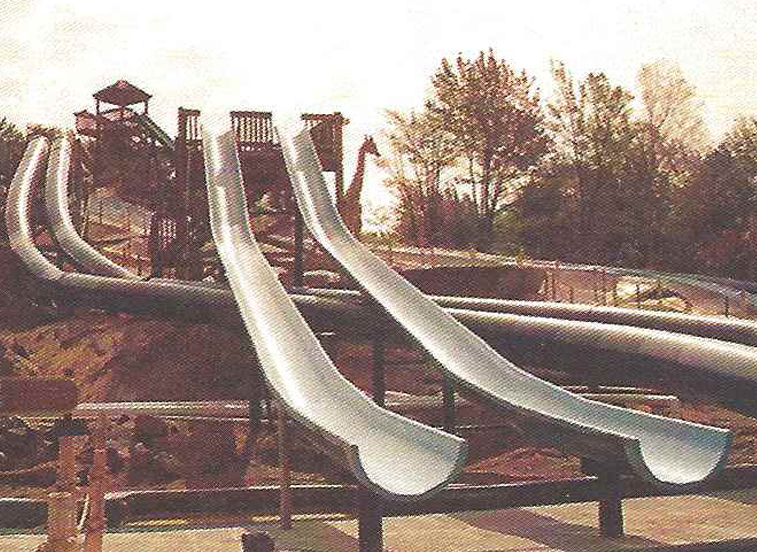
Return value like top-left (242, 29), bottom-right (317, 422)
top-left (0, 0), bottom-right (757, 220)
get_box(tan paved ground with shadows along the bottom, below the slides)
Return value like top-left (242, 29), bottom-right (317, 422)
top-left (0, 489), bottom-right (757, 552)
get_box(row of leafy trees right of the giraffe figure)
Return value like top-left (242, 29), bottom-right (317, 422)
top-left (381, 50), bottom-right (757, 278)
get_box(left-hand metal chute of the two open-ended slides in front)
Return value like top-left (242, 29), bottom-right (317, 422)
top-left (203, 131), bottom-right (467, 499)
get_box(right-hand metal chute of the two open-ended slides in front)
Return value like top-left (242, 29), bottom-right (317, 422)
top-left (279, 124), bottom-right (731, 486)
